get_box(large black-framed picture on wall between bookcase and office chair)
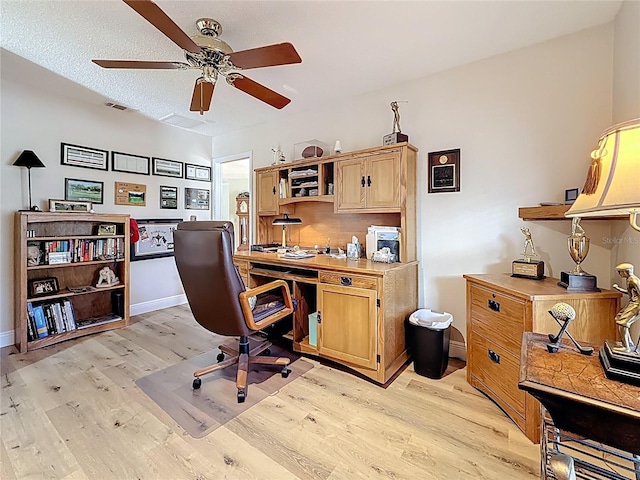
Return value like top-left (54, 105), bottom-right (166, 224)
top-left (130, 218), bottom-right (182, 261)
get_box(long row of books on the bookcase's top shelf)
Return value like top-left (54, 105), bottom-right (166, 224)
top-left (28, 238), bottom-right (126, 266)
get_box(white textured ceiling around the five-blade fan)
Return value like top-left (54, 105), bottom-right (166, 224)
top-left (0, 0), bottom-right (621, 136)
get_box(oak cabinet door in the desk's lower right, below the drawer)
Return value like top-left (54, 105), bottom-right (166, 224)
top-left (318, 284), bottom-right (378, 370)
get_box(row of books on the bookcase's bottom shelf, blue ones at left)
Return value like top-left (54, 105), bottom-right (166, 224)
top-left (27, 298), bottom-right (77, 341)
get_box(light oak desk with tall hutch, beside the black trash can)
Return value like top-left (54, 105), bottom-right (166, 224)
top-left (240, 143), bottom-right (418, 383)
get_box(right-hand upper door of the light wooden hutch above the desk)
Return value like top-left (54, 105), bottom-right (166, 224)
top-left (365, 153), bottom-right (400, 208)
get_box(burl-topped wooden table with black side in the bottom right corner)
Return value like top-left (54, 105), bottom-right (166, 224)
top-left (518, 333), bottom-right (640, 478)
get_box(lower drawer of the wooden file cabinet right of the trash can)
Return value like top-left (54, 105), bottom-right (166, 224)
top-left (469, 332), bottom-right (525, 416)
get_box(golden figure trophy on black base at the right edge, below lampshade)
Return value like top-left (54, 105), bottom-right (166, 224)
top-left (600, 263), bottom-right (640, 384)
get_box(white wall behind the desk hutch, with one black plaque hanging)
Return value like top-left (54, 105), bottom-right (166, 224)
top-left (214, 25), bottom-right (613, 344)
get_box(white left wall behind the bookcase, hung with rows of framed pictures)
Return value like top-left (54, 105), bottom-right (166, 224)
top-left (0, 72), bottom-right (212, 346)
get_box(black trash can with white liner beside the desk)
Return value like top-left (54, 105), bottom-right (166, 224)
top-left (405, 309), bottom-right (453, 379)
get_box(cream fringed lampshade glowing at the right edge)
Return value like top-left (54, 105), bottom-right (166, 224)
top-left (565, 118), bottom-right (640, 231)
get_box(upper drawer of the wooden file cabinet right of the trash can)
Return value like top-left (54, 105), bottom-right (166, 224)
top-left (469, 285), bottom-right (525, 356)
